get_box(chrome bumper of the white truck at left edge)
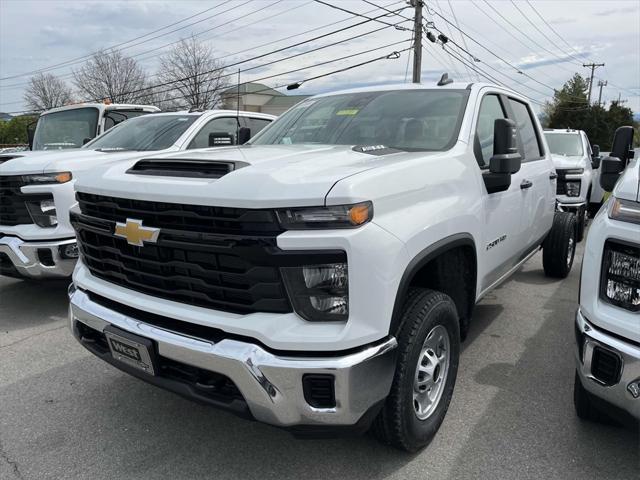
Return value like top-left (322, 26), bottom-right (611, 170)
top-left (0, 236), bottom-right (77, 279)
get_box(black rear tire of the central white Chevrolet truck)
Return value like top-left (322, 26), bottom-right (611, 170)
top-left (542, 212), bottom-right (576, 278)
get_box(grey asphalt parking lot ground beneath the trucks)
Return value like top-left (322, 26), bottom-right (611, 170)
top-left (0, 242), bottom-right (640, 480)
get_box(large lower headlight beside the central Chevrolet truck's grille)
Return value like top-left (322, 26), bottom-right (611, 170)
top-left (281, 263), bottom-right (349, 322)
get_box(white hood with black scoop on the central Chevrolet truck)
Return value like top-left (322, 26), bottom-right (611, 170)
top-left (76, 145), bottom-right (424, 208)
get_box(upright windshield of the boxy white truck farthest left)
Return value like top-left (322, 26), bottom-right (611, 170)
top-left (33, 107), bottom-right (98, 150)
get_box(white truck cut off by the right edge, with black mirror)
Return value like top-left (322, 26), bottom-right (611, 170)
top-left (574, 127), bottom-right (640, 420)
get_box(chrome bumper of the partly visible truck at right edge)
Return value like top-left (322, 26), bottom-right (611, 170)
top-left (575, 310), bottom-right (640, 419)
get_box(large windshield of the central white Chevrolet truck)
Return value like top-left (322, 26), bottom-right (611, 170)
top-left (250, 90), bottom-right (468, 151)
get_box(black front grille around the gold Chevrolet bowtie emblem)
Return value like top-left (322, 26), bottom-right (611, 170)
top-left (71, 193), bottom-right (291, 314)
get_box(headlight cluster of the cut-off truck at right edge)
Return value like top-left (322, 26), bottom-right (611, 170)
top-left (600, 241), bottom-right (640, 312)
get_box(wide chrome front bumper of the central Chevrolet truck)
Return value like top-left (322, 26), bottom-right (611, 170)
top-left (69, 287), bottom-right (397, 427)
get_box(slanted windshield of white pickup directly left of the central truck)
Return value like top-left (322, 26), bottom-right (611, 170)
top-left (85, 115), bottom-right (198, 152)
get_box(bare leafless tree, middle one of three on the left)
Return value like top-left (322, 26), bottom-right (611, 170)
top-left (73, 50), bottom-right (148, 103)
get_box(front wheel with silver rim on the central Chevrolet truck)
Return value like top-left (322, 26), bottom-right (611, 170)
top-left (372, 289), bottom-right (460, 452)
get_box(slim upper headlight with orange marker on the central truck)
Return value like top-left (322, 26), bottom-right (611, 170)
top-left (276, 202), bottom-right (373, 230)
